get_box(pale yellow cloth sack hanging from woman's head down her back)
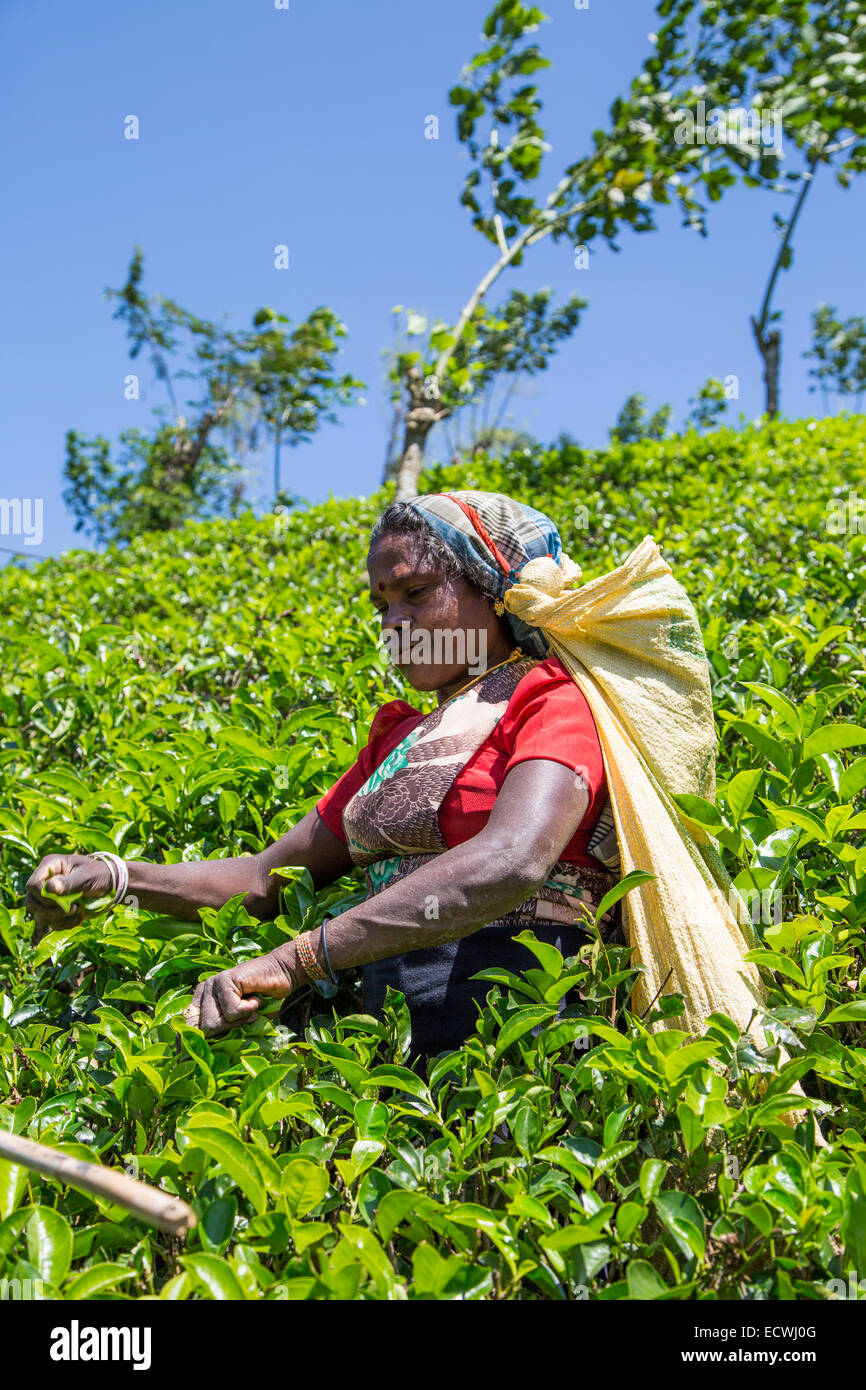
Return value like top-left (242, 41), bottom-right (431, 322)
top-left (505, 537), bottom-right (766, 1047)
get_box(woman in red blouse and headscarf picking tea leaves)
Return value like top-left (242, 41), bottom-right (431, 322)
top-left (28, 492), bottom-right (619, 1059)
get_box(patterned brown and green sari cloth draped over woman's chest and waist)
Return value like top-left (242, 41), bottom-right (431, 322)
top-left (343, 657), bottom-right (620, 1059)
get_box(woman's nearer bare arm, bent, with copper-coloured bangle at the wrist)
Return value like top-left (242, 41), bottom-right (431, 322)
top-left (188, 759), bottom-right (589, 1033)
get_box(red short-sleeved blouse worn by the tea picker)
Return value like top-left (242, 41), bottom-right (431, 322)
top-left (317, 656), bottom-right (607, 869)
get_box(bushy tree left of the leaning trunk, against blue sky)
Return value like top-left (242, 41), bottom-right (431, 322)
top-left (64, 249), bottom-right (360, 542)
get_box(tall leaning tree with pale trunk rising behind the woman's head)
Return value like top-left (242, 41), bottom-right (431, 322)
top-left (396, 0), bottom-right (817, 498)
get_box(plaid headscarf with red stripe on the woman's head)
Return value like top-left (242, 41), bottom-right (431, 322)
top-left (411, 491), bottom-right (567, 656)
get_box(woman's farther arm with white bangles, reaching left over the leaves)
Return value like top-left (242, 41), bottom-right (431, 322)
top-left (26, 808), bottom-right (353, 927)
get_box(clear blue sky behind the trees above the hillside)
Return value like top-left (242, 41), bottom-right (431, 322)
top-left (0, 0), bottom-right (866, 555)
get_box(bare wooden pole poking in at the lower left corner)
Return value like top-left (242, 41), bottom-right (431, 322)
top-left (0, 1130), bottom-right (197, 1236)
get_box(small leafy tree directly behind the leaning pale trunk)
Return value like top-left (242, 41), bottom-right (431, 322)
top-left (382, 289), bottom-right (587, 482)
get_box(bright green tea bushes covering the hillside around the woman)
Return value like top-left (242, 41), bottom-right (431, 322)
top-left (0, 418), bottom-right (866, 1300)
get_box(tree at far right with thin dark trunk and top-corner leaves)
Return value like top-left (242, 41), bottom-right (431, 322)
top-left (659, 0), bottom-right (866, 417)
